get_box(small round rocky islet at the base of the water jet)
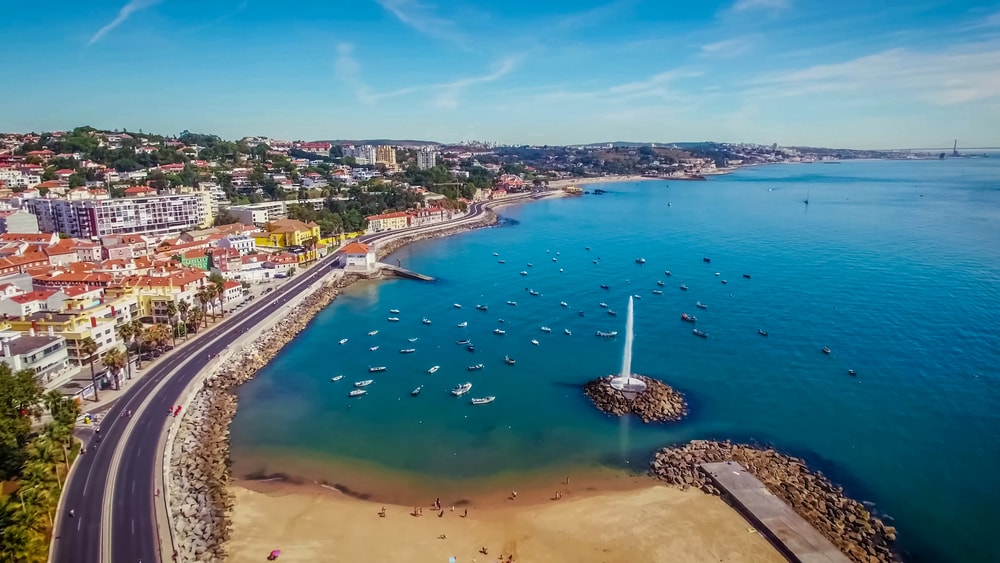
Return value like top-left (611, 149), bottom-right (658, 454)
top-left (583, 375), bottom-right (687, 423)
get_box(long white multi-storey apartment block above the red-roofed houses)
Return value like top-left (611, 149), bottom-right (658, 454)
top-left (26, 192), bottom-right (214, 238)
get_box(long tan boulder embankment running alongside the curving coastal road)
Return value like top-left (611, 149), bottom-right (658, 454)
top-left (167, 274), bottom-right (363, 561)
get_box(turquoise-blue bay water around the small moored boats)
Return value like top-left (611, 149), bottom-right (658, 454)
top-left (232, 158), bottom-right (1000, 562)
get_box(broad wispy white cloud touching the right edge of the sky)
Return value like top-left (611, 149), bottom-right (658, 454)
top-left (752, 43), bottom-right (1000, 106)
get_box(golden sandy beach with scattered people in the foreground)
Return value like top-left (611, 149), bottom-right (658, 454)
top-left (227, 479), bottom-right (785, 563)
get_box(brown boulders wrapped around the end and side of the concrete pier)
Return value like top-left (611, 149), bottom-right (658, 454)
top-left (652, 440), bottom-right (900, 563)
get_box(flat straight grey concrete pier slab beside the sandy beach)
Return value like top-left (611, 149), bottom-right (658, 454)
top-left (700, 461), bottom-right (850, 563)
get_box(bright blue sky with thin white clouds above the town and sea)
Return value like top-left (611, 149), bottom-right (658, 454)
top-left (0, 0), bottom-right (1000, 148)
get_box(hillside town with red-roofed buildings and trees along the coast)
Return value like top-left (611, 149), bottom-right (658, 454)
top-left (0, 127), bottom-right (916, 399)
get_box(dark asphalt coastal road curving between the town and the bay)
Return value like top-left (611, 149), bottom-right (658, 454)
top-left (49, 198), bottom-right (528, 563)
